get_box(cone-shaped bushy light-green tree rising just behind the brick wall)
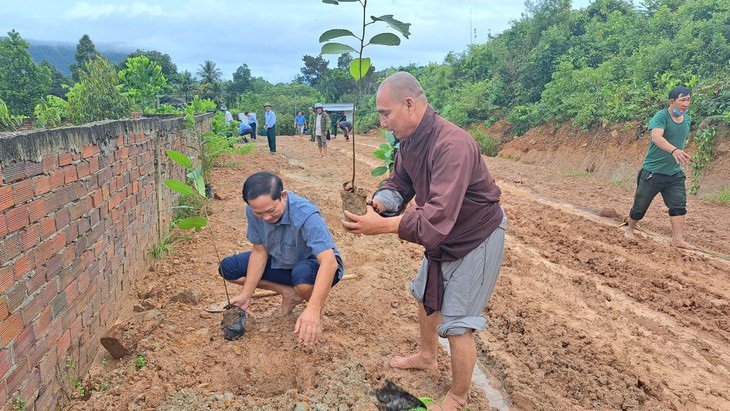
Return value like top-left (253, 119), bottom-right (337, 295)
top-left (66, 56), bottom-right (132, 124)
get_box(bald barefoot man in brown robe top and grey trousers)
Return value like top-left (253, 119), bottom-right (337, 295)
top-left (342, 72), bottom-right (507, 410)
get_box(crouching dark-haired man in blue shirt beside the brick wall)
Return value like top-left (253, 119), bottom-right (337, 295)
top-left (219, 171), bottom-right (344, 345)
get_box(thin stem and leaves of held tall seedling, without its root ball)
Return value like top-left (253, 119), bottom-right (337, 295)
top-left (319, 0), bottom-right (411, 191)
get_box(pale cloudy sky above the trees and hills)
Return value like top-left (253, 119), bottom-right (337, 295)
top-left (0, 0), bottom-right (590, 83)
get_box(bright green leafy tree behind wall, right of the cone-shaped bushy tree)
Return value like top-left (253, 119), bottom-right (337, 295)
top-left (119, 56), bottom-right (170, 112)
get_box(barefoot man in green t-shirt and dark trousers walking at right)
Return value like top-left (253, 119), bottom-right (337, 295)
top-left (625, 86), bottom-right (694, 249)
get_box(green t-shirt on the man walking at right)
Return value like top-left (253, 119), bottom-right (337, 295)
top-left (641, 109), bottom-right (692, 176)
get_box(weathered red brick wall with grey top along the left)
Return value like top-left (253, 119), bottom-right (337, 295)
top-left (0, 115), bottom-right (211, 410)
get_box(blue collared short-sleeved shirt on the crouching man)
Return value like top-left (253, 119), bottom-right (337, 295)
top-left (246, 191), bottom-right (340, 270)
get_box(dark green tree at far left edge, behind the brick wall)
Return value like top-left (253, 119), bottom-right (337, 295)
top-left (0, 30), bottom-right (51, 116)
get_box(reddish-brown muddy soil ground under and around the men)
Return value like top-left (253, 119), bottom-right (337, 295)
top-left (71, 130), bottom-right (730, 410)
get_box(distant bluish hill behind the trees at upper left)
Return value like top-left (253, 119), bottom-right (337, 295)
top-left (28, 40), bottom-right (134, 76)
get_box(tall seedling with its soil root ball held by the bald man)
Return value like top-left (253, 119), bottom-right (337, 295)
top-left (319, 0), bottom-right (411, 215)
